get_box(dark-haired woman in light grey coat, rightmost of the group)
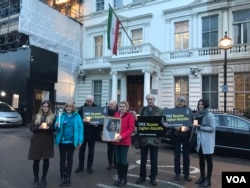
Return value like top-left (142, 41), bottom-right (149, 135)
top-left (195, 99), bottom-right (216, 187)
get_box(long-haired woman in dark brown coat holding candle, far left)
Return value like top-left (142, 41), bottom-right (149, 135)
top-left (28, 100), bottom-right (55, 188)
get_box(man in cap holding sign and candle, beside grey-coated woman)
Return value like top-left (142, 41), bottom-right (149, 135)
top-left (173, 96), bottom-right (193, 181)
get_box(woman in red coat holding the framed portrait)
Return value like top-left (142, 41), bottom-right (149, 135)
top-left (114, 101), bottom-right (135, 187)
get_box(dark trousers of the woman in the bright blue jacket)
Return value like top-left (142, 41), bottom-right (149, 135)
top-left (59, 143), bottom-right (75, 177)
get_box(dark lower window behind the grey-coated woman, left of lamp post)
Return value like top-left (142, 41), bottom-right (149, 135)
top-left (202, 75), bottom-right (219, 109)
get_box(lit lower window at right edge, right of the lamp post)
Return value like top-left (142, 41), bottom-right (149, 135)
top-left (234, 72), bottom-right (250, 110)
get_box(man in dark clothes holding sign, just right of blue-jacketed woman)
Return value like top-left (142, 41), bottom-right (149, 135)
top-left (75, 95), bottom-right (99, 174)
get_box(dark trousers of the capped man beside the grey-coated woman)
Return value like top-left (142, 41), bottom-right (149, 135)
top-left (174, 136), bottom-right (190, 176)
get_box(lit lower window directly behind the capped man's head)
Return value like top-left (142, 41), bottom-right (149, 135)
top-left (174, 76), bottom-right (189, 106)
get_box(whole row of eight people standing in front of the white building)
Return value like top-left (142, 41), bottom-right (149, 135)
top-left (28, 94), bottom-right (215, 188)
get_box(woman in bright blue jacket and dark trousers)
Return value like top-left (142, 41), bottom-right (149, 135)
top-left (55, 102), bottom-right (84, 186)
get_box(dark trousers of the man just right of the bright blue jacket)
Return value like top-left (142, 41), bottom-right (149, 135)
top-left (79, 139), bottom-right (95, 169)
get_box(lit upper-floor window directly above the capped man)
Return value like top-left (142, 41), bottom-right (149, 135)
top-left (174, 21), bottom-right (189, 50)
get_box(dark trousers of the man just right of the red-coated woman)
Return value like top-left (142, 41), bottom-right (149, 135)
top-left (140, 145), bottom-right (158, 179)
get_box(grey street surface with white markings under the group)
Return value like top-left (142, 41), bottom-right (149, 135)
top-left (0, 127), bottom-right (250, 188)
